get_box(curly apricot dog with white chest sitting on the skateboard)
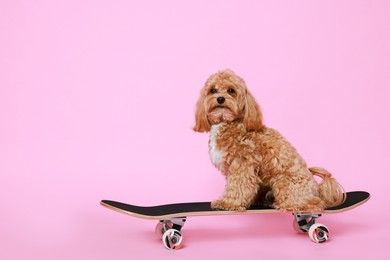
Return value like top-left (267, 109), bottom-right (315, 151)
top-left (193, 70), bottom-right (345, 212)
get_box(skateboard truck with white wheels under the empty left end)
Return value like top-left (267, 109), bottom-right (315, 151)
top-left (156, 217), bottom-right (187, 249)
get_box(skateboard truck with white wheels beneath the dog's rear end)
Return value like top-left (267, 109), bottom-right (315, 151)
top-left (293, 213), bottom-right (329, 243)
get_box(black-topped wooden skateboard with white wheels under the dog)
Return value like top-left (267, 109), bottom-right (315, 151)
top-left (100, 191), bottom-right (370, 249)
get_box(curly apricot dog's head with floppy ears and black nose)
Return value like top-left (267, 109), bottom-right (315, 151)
top-left (194, 70), bottom-right (263, 132)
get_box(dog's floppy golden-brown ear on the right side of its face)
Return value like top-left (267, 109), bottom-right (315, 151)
top-left (243, 90), bottom-right (263, 131)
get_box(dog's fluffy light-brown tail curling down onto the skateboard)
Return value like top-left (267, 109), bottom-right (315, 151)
top-left (309, 167), bottom-right (346, 208)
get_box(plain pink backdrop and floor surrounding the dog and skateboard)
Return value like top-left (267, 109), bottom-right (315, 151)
top-left (0, 0), bottom-right (390, 259)
